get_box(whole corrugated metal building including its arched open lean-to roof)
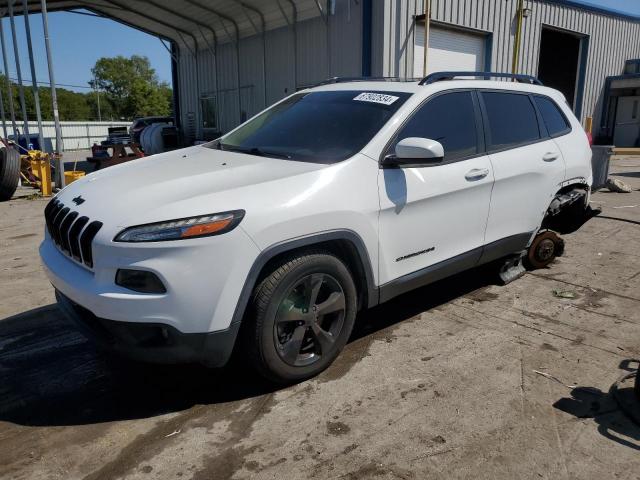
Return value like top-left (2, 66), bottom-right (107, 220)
top-left (12, 0), bottom-right (640, 142)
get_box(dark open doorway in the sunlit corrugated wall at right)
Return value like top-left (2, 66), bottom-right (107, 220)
top-left (538, 28), bottom-right (582, 111)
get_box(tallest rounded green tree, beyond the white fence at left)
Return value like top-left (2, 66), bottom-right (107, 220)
top-left (89, 55), bottom-right (171, 120)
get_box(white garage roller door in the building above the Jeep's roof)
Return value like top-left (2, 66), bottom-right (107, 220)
top-left (413, 24), bottom-right (486, 77)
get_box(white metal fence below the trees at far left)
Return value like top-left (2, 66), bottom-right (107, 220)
top-left (7, 121), bottom-right (131, 152)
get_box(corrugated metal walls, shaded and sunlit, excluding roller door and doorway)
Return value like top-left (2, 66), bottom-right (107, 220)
top-left (177, 0), bottom-right (640, 139)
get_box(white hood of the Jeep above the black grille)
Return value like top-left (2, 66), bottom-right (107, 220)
top-left (58, 146), bottom-right (326, 226)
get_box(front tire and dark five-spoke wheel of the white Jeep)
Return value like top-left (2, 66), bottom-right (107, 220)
top-left (244, 252), bottom-right (357, 384)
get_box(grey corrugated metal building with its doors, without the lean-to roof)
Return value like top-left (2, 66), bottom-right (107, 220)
top-left (171, 0), bottom-right (640, 144)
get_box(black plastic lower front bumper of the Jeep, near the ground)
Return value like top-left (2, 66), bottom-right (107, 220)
top-left (56, 290), bottom-right (240, 367)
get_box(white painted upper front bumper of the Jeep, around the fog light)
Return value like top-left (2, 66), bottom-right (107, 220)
top-left (40, 224), bottom-right (259, 334)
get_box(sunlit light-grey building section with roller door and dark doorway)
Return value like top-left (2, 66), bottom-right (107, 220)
top-left (373, 0), bottom-right (640, 144)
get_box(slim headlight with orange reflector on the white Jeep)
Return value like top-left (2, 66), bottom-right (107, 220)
top-left (114, 210), bottom-right (245, 242)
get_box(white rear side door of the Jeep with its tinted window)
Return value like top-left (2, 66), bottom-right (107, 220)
top-left (480, 90), bottom-right (565, 251)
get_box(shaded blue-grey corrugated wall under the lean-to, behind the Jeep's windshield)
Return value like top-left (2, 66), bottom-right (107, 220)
top-left (176, 0), bottom-right (364, 140)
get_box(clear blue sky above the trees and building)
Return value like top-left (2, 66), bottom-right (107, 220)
top-left (3, 0), bottom-right (640, 91)
